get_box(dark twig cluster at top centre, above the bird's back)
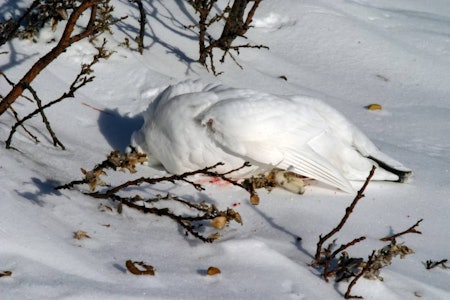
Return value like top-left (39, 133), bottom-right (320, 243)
top-left (187, 0), bottom-right (268, 75)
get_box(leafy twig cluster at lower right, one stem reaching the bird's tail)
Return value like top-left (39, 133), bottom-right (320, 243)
top-left (311, 167), bottom-right (422, 299)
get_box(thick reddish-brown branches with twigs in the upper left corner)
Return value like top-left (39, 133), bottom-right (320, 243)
top-left (0, 0), bottom-right (119, 149)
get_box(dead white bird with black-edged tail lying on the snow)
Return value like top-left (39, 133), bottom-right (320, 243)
top-left (131, 81), bottom-right (412, 193)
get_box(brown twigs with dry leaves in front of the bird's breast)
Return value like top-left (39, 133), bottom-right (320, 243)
top-left (56, 151), bottom-right (253, 243)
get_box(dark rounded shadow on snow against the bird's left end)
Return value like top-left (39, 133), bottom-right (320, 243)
top-left (97, 109), bottom-right (144, 152)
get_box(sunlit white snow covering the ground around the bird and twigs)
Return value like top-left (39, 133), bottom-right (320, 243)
top-left (0, 0), bottom-right (450, 299)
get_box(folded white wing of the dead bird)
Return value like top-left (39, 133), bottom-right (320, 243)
top-left (197, 90), bottom-right (353, 192)
